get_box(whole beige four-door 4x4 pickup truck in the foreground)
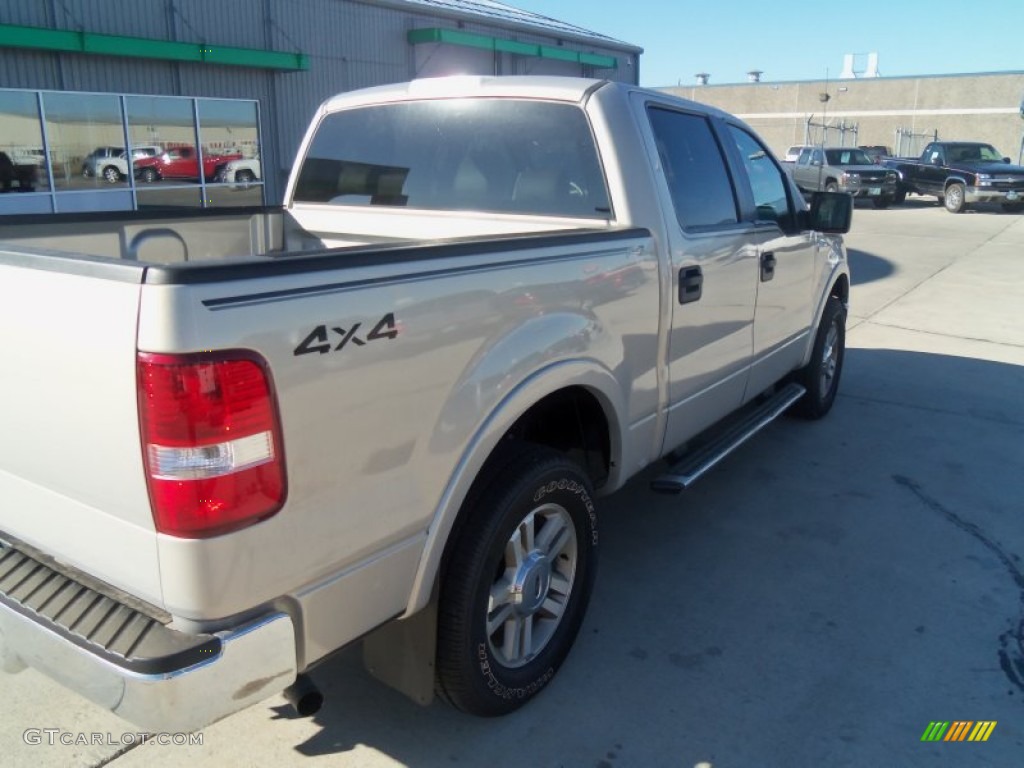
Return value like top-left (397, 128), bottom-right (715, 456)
top-left (0, 78), bottom-right (852, 730)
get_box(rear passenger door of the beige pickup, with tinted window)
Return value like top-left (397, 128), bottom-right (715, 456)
top-left (644, 102), bottom-right (758, 452)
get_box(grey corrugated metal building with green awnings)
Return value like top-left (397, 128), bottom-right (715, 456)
top-left (0, 0), bottom-right (642, 214)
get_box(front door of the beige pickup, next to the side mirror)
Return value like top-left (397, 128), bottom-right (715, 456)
top-left (727, 123), bottom-right (818, 399)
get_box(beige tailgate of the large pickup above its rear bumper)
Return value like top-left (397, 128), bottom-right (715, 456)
top-left (0, 256), bottom-right (162, 604)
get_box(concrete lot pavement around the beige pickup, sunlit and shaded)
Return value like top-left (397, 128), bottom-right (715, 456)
top-left (0, 203), bottom-right (1024, 768)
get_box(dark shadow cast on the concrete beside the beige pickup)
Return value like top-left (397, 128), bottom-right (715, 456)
top-left (275, 348), bottom-right (1024, 768)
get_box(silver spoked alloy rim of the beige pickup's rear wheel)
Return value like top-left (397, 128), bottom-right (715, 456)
top-left (486, 504), bottom-right (578, 668)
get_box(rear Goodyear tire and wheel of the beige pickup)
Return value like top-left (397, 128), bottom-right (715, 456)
top-left (437, 444), bottom-right (597, 716)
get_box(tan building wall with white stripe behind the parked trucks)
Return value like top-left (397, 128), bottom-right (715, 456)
top-left (660, 72), bottom-right (1024, 162)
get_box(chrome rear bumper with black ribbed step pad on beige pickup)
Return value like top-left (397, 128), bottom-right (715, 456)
top-left (0, 542), bottom-right (298, 732)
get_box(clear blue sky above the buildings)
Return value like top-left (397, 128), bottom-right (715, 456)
top-left (516, 0), bottom-right (1024, 87)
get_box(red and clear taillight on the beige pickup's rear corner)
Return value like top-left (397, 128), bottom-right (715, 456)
top-left (138, 352), bottom-right (285, 539)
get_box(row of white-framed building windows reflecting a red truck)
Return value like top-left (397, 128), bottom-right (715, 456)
top-left (0, 89), bottom-right (264, 215)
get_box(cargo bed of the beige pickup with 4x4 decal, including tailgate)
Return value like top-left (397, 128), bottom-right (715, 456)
top-left (0, 211), bottom-right (659, 626)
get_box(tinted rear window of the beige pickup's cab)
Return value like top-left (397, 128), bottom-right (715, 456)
top-left (294, 98), bottom-right (610, 218)
